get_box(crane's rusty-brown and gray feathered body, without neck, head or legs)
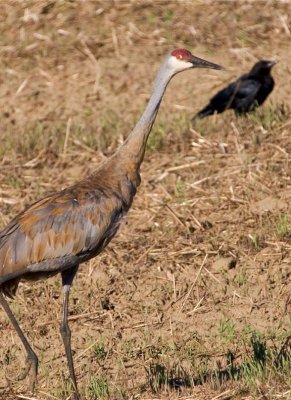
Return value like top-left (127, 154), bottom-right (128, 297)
top-left (0, 156), bottom-right (140, 297)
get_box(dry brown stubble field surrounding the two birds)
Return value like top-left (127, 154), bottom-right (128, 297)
top-left (0, 0), bottom-right (291, 400)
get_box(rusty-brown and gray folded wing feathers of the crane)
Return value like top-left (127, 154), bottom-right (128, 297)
top-left (0, 180), bottom-right (122, 286)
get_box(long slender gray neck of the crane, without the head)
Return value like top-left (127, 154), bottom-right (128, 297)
top-left (117, 62), bottom-right (174, 168)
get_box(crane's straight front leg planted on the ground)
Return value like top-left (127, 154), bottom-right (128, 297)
top-left (60, 265), bottom-right (80, 400)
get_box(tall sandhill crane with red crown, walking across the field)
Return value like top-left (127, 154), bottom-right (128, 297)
top-left (0, 49), bottom-right (223, 400)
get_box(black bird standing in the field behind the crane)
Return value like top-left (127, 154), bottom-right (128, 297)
top-left (192, 60), bottom-right (276, 121)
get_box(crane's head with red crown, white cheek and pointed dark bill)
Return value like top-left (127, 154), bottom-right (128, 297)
top-left (169, 49), bottom-right (224, 72)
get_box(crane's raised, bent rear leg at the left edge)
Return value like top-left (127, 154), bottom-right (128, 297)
top-left (0, 291), bottom-right (38, 392)
